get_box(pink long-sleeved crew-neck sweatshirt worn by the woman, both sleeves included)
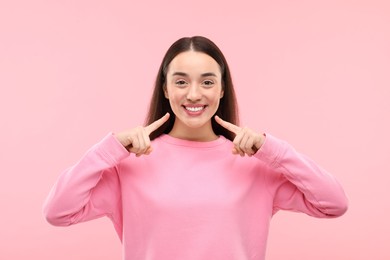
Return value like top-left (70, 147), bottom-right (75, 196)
top-left (44, 134), bottom-right (347, 260)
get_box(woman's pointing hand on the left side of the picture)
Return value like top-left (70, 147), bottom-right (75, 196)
top-left (115, 113), bottom-right (169, 157)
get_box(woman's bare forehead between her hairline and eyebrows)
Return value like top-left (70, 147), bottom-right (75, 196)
top-left (167, 51), bottom-right (221, 75)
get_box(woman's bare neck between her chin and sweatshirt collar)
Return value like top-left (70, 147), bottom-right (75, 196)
top-left (169, 121), bottom-right (219, 142)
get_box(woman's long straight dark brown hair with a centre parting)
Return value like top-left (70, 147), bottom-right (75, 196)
top-left (145, 36), bottom-right (239, 141)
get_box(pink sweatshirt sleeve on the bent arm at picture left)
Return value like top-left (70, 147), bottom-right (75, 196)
top-left (43, 133), bottom-right (129, 231)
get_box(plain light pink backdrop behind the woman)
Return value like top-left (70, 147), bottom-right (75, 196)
top-left (0, 0), bottom-right (390, 260)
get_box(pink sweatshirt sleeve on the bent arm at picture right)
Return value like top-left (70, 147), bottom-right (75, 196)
top-left (255, 134), bottom-right (348, 218)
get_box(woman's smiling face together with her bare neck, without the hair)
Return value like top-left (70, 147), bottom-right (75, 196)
top-left (165, 51), bottom-right (223, 138)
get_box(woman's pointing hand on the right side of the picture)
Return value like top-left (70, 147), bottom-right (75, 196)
top-left (215, 116), bottom-right (265, 156)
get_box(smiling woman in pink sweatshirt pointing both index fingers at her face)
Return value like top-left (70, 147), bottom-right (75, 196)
top-left (44, 36), bottom-right (347, 260)
